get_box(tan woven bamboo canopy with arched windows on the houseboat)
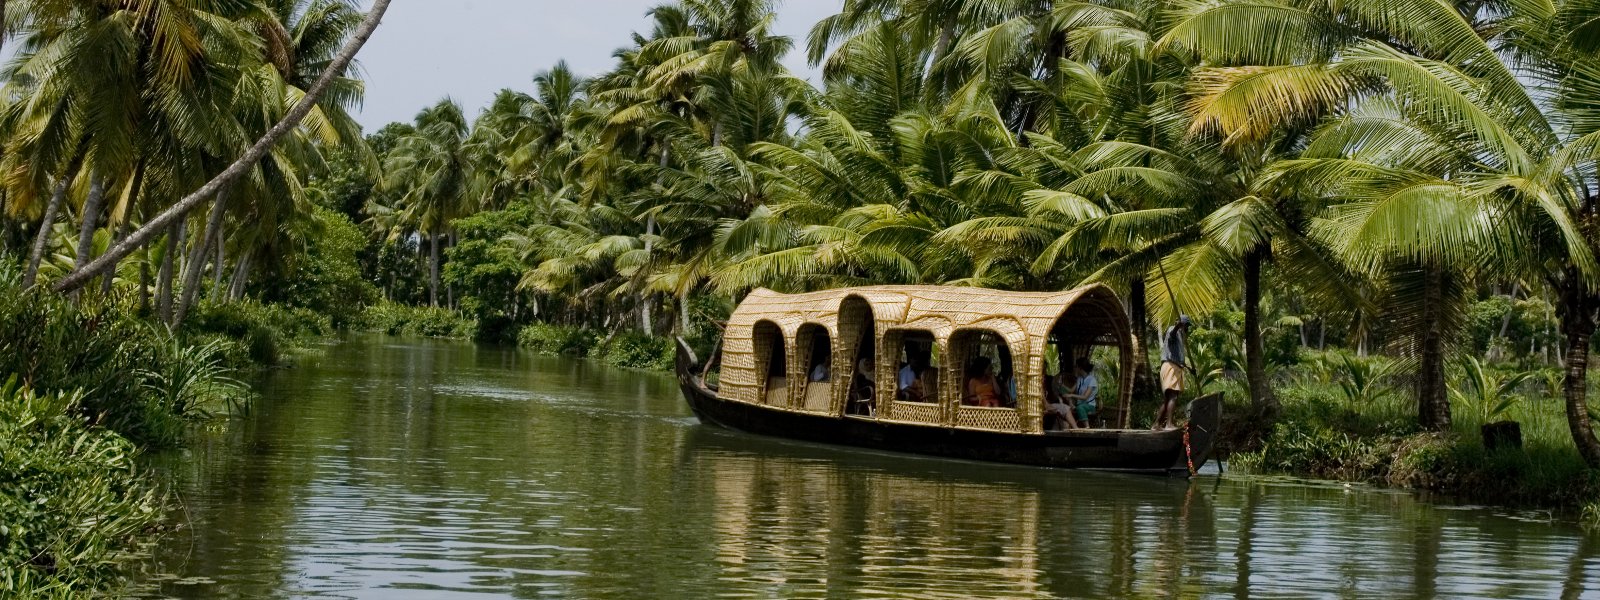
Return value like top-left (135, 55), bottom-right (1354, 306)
top-left (718, 285), bottom-right (1133, 434)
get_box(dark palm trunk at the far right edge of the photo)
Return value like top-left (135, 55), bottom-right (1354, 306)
top-left (1558, 273), bottom-right (1600, 469)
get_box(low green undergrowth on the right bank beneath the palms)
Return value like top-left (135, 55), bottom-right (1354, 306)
top-left (1211, 355), bottom-right (1600, 526)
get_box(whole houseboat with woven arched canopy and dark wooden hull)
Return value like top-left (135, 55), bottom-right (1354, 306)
top-left (677, 286), bottom-right (1221, 474)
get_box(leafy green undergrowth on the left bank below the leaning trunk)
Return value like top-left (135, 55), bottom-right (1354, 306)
top-left (0, 269), bottom-right (254, 597)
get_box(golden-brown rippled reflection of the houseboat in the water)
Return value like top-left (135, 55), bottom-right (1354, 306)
top-left (675, 427), bottom-right (1218, 598)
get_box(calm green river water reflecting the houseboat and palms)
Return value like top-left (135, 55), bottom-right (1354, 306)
top-left (136, 338), bottom-right (1600, 598)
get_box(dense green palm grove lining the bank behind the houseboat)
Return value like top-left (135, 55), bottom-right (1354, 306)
top-left (337, 0), bottom-right (1600, 466)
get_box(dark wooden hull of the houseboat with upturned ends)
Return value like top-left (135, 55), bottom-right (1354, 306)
top-left (677, 341), bottom-right (1221, 475)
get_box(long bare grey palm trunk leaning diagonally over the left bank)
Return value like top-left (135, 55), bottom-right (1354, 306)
top-left (54, 0), bottom-right (392, 291)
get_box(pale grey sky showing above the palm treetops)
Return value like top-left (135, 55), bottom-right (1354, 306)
top-left (357, 0), bottom-right (842, 133)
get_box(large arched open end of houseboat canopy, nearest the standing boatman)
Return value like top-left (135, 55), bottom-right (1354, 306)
top-left (1043, 288), bottom-right (1133, 429)
